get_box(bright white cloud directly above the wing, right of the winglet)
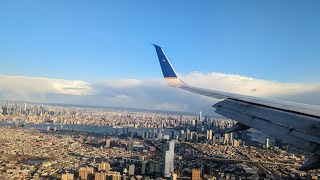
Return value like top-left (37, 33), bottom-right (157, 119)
top-left (184, 72), bottom-right (320, 97)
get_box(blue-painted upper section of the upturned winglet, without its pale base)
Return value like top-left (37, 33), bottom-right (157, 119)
top-left (153, 44), bottom-right (178, 78)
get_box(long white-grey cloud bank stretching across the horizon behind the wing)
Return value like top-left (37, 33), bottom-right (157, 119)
top-left (0, 72), bottom-right (320, 112)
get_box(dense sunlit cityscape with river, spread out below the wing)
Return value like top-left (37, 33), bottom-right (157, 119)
top-left (0, 103), bottom-right (320, 180)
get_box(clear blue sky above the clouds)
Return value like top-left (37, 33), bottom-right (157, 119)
top-left (0, 0), bottom-right (320, 82)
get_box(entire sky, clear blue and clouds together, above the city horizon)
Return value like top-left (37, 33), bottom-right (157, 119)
top-left (0, 0), bottom-right (320, 112)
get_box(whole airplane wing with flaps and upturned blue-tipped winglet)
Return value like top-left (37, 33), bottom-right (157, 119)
top-left (154, 44), bottom-right (320, 170)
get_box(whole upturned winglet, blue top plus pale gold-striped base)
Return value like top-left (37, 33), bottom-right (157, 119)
top-left (153, 44), bottom-right (183, 87)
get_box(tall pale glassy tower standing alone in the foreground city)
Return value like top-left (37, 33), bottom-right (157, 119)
top-left (162, 141), bottom-right (174, 177)
